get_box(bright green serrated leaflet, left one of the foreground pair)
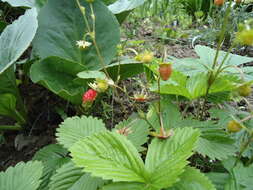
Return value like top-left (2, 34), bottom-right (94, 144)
top-left (70, 131), bottom-right (147, 182)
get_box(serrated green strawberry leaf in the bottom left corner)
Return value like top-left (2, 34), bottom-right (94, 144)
top-left (0, 161), bottom-right (43, 190)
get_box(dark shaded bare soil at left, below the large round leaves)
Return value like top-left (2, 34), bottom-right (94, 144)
top-left (0, 84), bottom-right (62, 171)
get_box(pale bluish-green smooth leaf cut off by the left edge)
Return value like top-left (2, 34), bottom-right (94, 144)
top-left (0, 9), bottom-right (38, 74)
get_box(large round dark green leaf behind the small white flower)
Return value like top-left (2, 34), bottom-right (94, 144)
top-left (33, 0), bottom-right (119, 72)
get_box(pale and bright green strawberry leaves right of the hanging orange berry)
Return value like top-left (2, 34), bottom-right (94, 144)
top-left (146, 45), bottom-right (253, 101)
